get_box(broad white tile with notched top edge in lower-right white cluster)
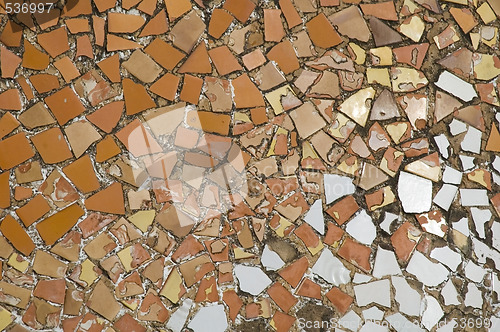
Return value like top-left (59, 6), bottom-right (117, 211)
top-left (406, 251), bottom-right (448, 287)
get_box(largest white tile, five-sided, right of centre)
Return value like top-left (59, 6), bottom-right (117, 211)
top-left (398, 172), bottom-right (432, 213)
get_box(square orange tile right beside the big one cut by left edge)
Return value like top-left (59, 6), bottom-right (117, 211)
top-left (31, 127), bottom-right (73, 164)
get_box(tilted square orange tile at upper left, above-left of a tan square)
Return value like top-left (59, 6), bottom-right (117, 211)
top-left (45, 86), bottom-right (85, 125)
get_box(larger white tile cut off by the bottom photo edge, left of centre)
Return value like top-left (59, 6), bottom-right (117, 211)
top-left (188, 304), bottom-right (228, 332)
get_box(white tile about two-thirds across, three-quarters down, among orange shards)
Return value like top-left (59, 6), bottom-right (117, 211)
top-left (312, 248), bottom-right (351, 286)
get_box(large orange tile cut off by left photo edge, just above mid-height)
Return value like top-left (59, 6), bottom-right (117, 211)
top-left (0, 133), bottom-right (35, 169)
